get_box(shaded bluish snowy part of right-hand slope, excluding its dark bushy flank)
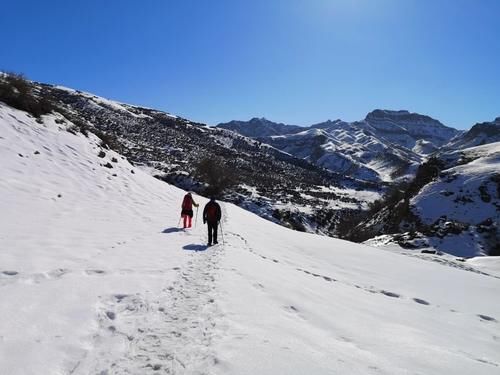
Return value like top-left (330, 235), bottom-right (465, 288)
top-left (411, 142), bottom-right (500, 256)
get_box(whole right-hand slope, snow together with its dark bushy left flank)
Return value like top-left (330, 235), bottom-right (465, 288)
top-left (358, 142), bottom-right (500, 258)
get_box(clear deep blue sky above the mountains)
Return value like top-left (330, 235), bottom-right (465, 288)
top-left (0, 0), bottom-right (500, 128)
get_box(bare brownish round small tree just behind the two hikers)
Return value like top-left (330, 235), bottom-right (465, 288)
top-left (194, 157), bottom-right (238, 197)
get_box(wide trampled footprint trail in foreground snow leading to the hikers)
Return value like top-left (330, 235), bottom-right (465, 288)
top-left (73, 233), bottom-right (224, 375)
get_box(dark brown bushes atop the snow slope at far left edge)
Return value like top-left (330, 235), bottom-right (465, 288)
top-left (0, 73), bottom-right (54, 117)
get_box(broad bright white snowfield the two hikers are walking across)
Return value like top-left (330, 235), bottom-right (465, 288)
top-left (0, 104), bottom-right (500, 375)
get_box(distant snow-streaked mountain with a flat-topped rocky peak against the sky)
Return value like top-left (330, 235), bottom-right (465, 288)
top-left (218, 110), bottom-right (460, 181)
